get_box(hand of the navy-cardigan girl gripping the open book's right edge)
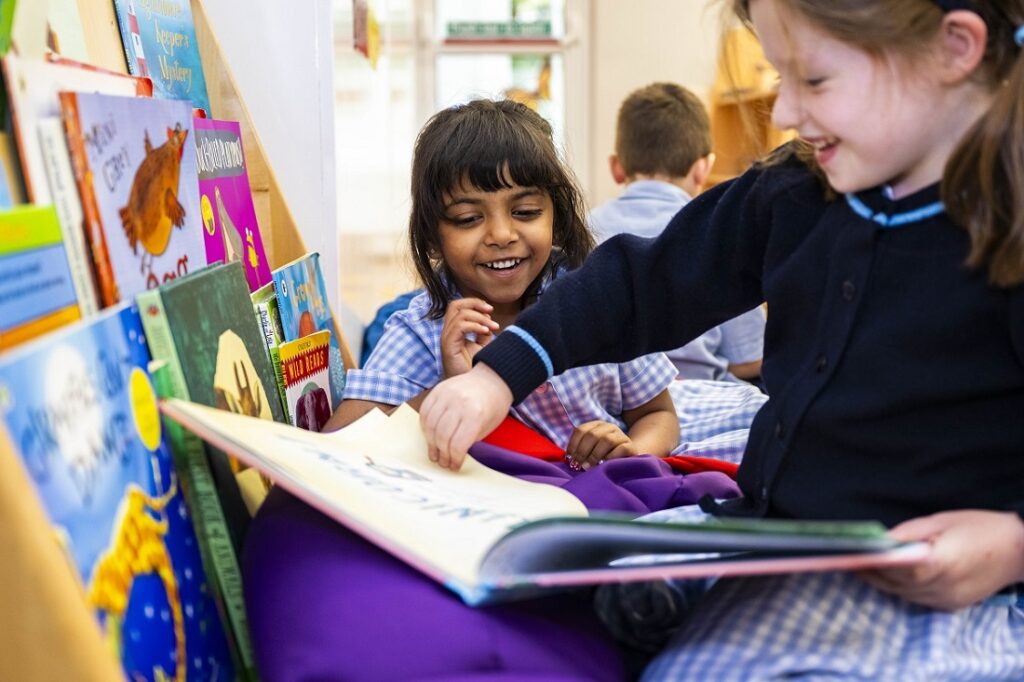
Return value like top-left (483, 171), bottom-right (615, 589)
top-left (860, 509), bottom-right (1024, 610)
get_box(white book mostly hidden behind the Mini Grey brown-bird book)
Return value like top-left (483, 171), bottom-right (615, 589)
top-left (3, 52), bottom-right (153, 204)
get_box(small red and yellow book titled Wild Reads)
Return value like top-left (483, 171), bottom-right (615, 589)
top-left (278, 330), bottom-right (331, 431)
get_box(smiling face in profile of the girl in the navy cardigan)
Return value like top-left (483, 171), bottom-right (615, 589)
top-left (750, 0), bottom-right (971, 197)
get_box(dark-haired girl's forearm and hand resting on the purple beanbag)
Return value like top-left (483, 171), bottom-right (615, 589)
top-left (565, 389), bottom-right (679, 469)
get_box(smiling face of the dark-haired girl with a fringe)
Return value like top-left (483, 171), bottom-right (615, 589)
top-left (438, 175), bottom-right (554, 327)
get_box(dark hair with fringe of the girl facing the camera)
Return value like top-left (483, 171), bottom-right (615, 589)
top-left (409, 99), bottom-right (594, 318)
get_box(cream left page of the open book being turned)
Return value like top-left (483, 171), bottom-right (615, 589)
top-left (161, 399), bottom-right (587, 594)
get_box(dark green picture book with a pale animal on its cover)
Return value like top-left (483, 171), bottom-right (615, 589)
top-left (136, 261), bottom-right (285, 671)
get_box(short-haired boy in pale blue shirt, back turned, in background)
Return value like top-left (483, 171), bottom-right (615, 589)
top-left (590, 83), bottom-right (765, 381)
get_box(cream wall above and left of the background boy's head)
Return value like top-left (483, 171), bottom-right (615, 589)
top-left (587, 0), bottom-right (725, 206)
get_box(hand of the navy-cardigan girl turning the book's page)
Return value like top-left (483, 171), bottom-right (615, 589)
top-left (420, 363), bottom-right (512, 471)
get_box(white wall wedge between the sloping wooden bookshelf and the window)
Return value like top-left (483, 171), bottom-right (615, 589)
top-left (202, 0), bottom-right (340, 310)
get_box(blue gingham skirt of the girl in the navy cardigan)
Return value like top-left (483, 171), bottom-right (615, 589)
top-left (596, 507), bottom-right (1024, 682)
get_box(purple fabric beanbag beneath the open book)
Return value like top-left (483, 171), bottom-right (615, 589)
top-left (242, 443), bottom-right (738, 682)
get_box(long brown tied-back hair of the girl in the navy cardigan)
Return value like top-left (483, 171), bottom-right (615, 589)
top-left (731, 0), bottom-right (1024, 287)
